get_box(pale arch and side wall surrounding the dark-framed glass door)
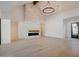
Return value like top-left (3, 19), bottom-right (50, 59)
top-left (64, 16), bottom-right (79, 38)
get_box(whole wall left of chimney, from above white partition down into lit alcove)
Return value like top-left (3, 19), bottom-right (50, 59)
top-left (2, 6), bottom-right (24, 40)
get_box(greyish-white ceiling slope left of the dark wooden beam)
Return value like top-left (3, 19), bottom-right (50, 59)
top-left (0, 1), bottom-right (30, 11)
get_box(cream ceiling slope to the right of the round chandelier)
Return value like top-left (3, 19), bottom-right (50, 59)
top-left (54, 1), bottom-right (79, 11)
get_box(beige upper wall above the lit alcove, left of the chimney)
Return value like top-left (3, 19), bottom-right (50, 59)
top-left (10, 6), bottom-right (24, 22)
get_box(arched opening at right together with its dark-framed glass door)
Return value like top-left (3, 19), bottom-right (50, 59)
top-left (64, 16), bottom-right (79, 39)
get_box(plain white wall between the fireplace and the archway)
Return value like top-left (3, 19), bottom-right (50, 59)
top-left (45, 14), bottom-right (63, 38)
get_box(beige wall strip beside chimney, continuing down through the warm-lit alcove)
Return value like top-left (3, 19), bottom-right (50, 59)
top-left (10, 6), bottom-right (24, 40)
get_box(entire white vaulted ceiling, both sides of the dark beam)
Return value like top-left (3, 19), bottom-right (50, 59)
top-left (0, 1), bottom-right (79, 11)
